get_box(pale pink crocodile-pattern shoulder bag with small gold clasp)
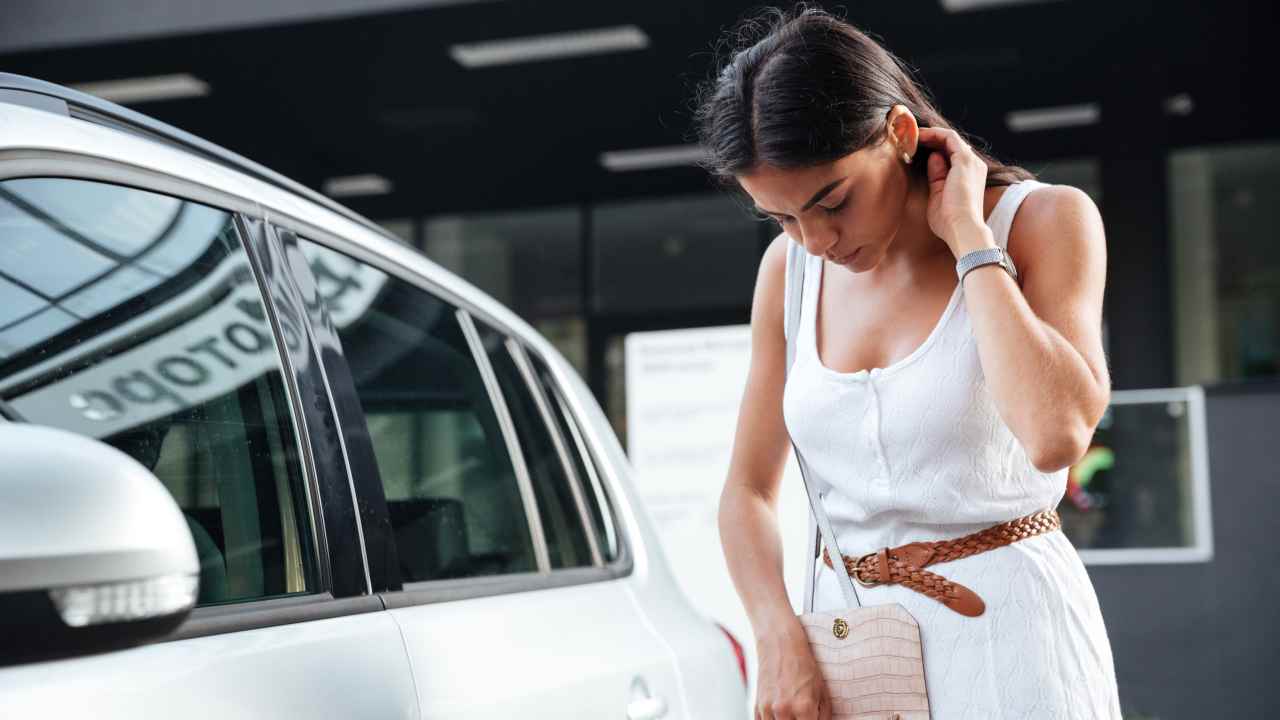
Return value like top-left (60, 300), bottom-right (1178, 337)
top-left (799, 603), bottom-right (929, 720)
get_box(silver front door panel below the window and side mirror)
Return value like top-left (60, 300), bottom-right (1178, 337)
top-left (0, 611), bottom-right (420, 720)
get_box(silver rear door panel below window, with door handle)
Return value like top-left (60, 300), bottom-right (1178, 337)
top-left (389, 580), bottom-right (694, 720)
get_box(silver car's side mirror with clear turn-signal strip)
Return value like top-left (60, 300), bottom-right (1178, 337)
top-left (0, 420), bottom-right (200, 664)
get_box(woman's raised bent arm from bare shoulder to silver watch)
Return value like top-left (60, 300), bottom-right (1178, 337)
top-left (956, 186), bottom-right (1111, 473)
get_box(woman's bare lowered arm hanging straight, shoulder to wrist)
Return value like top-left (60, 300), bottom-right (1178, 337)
top-left (719, 234), bottom-right (795, 639)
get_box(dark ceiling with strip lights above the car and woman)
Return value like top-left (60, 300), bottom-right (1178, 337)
top-left (0, 0), bottom-right (1280, 218)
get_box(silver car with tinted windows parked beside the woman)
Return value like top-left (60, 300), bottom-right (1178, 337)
top-left (0, 74), bottom-right (749, 720)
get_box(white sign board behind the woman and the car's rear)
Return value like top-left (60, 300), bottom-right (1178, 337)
top-left (626, 325), bottom-right (809, 702)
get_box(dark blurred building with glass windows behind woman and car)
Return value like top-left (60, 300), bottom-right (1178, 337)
top-left (0, 0), bottom-right (1280, 717)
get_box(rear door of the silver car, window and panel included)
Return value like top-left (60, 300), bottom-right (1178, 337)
top-left (289, 233), bottom-right (684, 720)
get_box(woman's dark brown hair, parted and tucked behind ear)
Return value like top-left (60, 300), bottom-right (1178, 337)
top-left (694, 3), bottom-right (1034, 187)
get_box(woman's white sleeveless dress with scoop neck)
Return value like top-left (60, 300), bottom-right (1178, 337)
top-left (783, 181), bottom-right (1120, 720)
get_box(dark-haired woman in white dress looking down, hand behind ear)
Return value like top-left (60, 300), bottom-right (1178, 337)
top-left (696, 6), bottom-right (1120, 720)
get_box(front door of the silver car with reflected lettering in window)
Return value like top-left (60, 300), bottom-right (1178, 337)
top-left (0, 175), bottom-right (417, 719)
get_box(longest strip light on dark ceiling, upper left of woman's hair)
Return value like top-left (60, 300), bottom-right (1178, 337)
top-left (449, 26), bottom-right (649, 68)
